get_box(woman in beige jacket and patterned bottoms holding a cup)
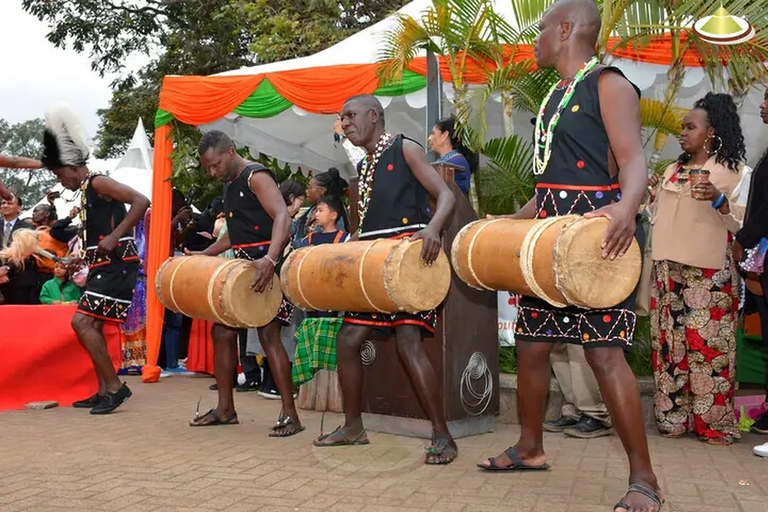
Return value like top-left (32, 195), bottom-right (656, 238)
top-left (651, 93), bottom-right (745, 445)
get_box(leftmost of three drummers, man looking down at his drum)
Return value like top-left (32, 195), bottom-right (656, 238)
top-left (190, 130), bottom-right (304, 437)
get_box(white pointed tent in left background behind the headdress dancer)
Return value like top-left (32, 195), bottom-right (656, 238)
top-left (20, 119), bottom-right (153, 222)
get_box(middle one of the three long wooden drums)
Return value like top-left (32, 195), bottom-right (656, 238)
top-left (280, 239), bottom-right (451, 313)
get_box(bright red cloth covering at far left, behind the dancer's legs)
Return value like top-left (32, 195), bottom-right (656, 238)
top-left (0, 305), bottom-right (120, 411)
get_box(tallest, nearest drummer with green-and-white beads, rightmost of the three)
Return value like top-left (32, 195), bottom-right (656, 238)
top-left (479, 0), bottom-right (662, 512)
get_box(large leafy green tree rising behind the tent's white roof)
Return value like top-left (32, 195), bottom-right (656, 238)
top-left (23, 0), bottom-right (408, 158)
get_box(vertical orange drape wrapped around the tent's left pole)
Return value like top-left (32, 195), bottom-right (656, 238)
top-left (141, 124), bottom-right (173, 382)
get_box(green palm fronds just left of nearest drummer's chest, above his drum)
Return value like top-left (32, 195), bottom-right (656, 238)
top-left (476, 135), bottom-right (536, 214)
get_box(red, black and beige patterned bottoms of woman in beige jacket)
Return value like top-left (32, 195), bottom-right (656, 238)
top-left (651, 249), bottom-right (739, 439)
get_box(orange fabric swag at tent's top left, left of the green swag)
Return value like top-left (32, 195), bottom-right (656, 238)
top-left (158, 75), bottom-right (264, 126)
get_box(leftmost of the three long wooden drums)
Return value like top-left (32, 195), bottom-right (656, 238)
top-left (155, 255), bottom-right (283, 328)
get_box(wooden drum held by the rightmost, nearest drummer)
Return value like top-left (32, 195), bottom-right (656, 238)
top-left (451, 215), bottom-right (642, 309)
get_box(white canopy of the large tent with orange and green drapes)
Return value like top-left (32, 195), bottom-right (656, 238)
top-left (200, 0), bottom-right (768, 177)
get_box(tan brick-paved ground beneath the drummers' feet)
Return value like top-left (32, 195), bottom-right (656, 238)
top-left (0, 376), bottom-right (768, 512)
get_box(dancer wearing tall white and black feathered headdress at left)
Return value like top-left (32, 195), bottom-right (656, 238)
top-left (42, 105), bottom-right (149, 414)
